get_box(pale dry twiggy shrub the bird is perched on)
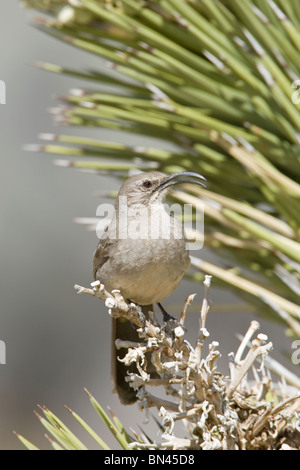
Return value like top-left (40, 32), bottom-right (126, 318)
top-left (75, 276), bottom-right (300, 450)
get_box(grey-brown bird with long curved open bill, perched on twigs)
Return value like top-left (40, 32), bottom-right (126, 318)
top-left (93, 171), bottom-right (205, 404)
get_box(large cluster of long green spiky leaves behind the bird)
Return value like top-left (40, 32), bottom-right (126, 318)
top-left (22, 0), bottom-right (300, 335)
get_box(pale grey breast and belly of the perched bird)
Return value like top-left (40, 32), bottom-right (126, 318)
top-left (99, 207), bottom-right (190, 305)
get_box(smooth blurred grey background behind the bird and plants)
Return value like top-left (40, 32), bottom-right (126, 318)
top-left (0, 0), bottom-right (298, 450)
